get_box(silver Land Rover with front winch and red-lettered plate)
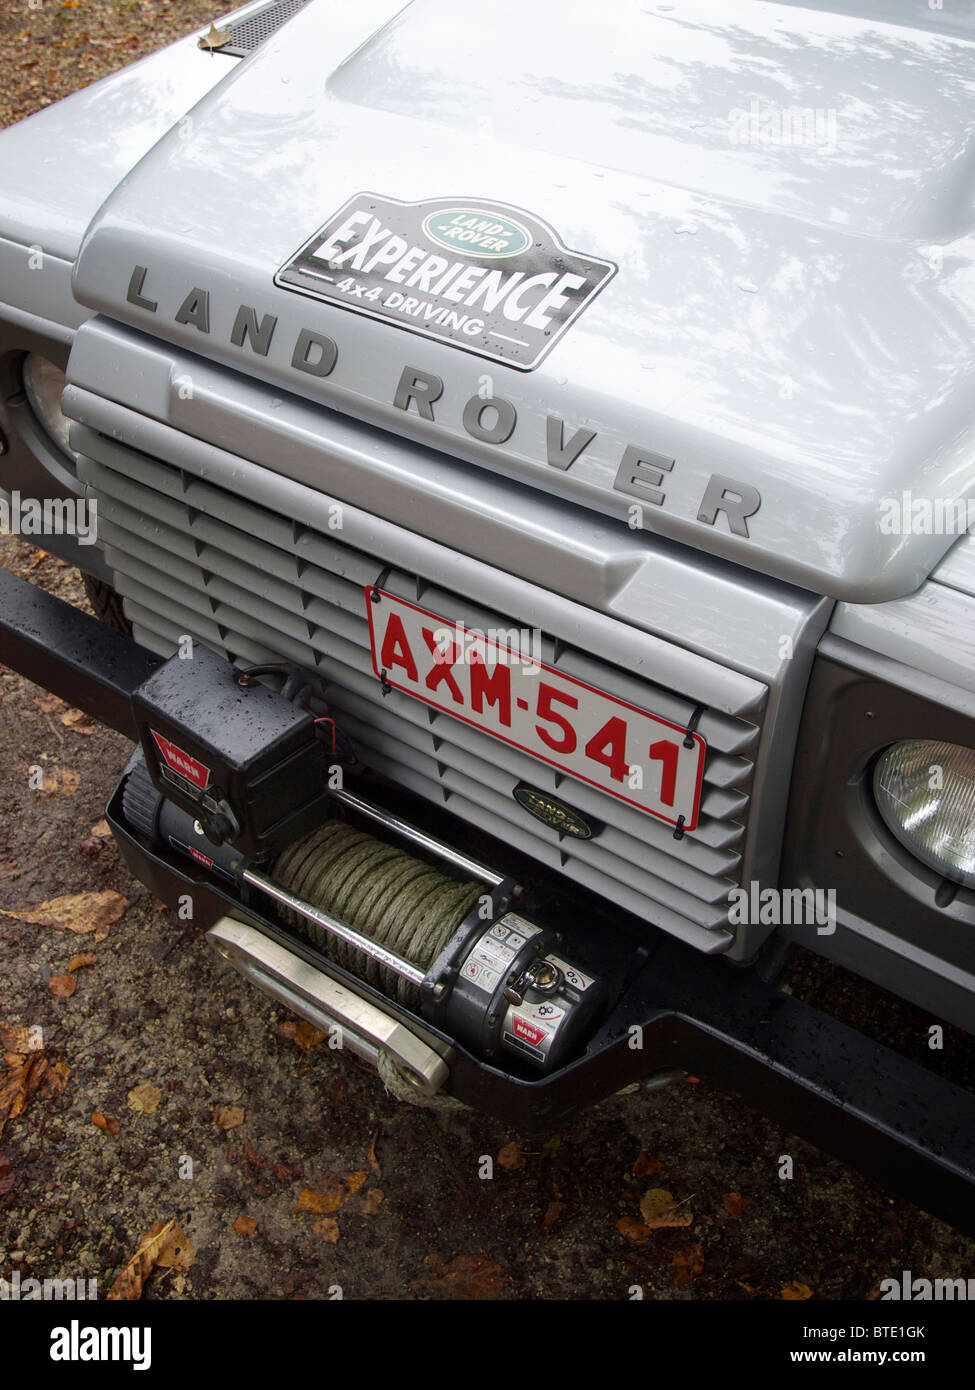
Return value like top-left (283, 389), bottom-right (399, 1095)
top-left (0, 0), bottom-right (975, 1223)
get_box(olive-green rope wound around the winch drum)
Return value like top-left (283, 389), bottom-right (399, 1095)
top-left (274, 820), bottom-right (484, 1008)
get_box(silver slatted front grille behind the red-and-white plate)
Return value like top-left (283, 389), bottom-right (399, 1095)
top-left (79, 431), bottom-right (761, 952)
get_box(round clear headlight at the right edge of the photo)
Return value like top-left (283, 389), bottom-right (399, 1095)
top-left (873, 738), bottom-right (975, 888)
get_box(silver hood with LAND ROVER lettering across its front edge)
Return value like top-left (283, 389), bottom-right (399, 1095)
top-left (74, 0), bottom-right (975, 602)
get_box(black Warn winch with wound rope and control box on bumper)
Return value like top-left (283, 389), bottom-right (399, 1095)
top-left (122, 649), bottom-right (606, 1072)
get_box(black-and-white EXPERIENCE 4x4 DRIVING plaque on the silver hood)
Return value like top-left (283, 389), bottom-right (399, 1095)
top-left (274, 193), bottom-right (616, 371)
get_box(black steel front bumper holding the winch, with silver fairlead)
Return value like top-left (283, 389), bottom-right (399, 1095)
top-left (0, 570), bottom-right (975, 1233)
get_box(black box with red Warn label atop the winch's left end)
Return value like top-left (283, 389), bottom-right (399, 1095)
top-left (132, 642), bottom-right (328, 862)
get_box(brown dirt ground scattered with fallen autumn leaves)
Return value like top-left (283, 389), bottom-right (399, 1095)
top-left (0, 0), bottom-right (975, 1301)
